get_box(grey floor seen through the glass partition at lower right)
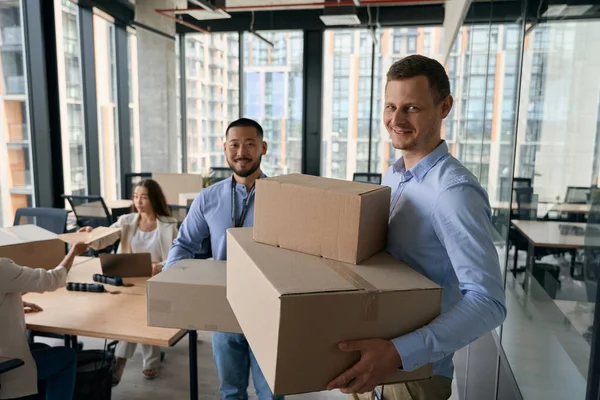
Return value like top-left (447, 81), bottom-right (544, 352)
top-left (501, 248), bottom-right (593, 400)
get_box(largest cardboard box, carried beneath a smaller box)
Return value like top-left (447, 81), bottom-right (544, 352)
top-left (227, 228), bottom-right (442, 395)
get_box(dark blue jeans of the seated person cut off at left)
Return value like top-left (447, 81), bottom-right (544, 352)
top-left (29, 343), bottom-right (77, 400)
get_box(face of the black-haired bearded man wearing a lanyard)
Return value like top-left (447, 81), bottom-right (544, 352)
top-left (225, 126), bottom-right (267, 178)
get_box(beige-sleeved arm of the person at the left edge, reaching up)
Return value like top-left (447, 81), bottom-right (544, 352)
top-left (0, 243), bottom-right (87, 293)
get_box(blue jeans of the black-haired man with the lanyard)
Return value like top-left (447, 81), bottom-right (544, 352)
top-left (212, 332), bottom-right (283, 400)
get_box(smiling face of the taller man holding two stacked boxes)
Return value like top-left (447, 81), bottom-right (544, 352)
top-left (383, 76), bottom-right (452, 154)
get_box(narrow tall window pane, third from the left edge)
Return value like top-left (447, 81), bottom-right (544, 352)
top-left (92, 15), bottom-right (121, 200)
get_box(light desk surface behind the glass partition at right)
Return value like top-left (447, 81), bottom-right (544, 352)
top-left (511, 220), bottom-right (585, 249)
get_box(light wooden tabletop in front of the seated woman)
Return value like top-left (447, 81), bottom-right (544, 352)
top-left (23, 257), bottom-right (185, 347)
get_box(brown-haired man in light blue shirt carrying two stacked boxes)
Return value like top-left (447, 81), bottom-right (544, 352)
top-left (329, 55), bottom-right (506, 400)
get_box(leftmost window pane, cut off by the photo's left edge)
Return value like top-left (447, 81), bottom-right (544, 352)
top-left (0, 1), bottom-right (33, 226)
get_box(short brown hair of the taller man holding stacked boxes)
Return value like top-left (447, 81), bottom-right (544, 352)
top-left (386, 54), bottom-right (450, 104)
